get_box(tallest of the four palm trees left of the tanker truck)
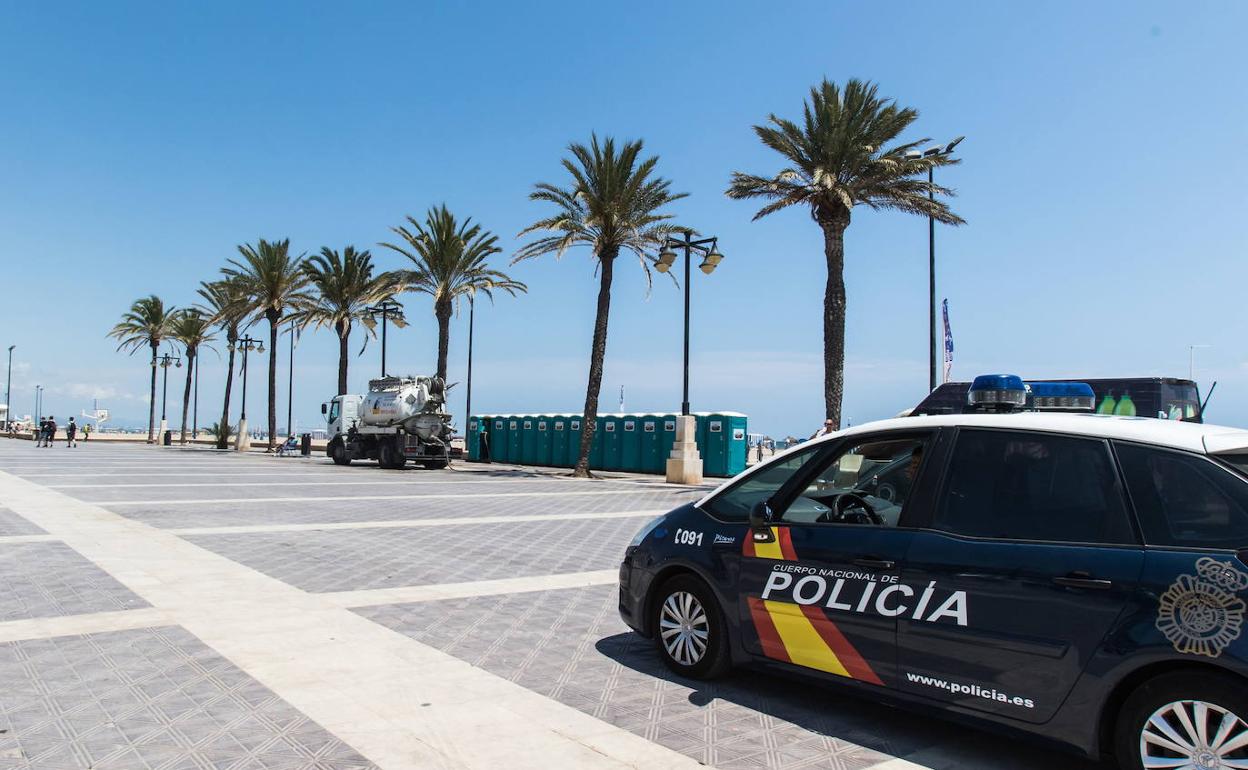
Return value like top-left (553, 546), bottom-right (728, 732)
top-left (221, 238), bottom-right (312, 451)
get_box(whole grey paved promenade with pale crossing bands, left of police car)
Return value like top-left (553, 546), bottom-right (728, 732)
top-left (0, 439), bottom-right (1091, 770)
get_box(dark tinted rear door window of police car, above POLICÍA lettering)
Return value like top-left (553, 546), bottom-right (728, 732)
top-left (932, 429), bottom-right (1134, 544)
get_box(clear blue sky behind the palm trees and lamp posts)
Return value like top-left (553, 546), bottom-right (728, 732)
top-left (0, 1), bottom-right (1248, 436)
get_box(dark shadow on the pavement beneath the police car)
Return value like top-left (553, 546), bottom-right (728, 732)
top-left (595, 633), bottom-right (1111, 770)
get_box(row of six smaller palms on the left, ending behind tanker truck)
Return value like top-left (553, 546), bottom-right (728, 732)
top-left (109, 205), bottom-right (527, 449)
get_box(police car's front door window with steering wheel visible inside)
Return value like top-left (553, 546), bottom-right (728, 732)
top-left (776, 437), bottom-right (926, 527)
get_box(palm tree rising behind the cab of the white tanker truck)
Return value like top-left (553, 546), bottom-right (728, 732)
top-left (295, 246), bottom-right (402, 394)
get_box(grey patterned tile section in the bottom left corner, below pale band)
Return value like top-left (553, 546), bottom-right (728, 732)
top-left (0, 628), bottom-right (374, 770)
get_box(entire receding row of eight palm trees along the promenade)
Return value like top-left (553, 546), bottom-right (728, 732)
top-left (112, 80), bottom-right (962, 475)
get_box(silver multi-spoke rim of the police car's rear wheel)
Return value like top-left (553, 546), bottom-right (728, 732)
top-left (1139, 700), bottom-right (1248, 770)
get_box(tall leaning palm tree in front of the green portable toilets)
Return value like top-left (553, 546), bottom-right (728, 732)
top-left (513, 135), bottom-right (685, 477)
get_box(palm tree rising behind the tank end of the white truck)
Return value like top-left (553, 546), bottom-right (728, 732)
top-left (382, 203), bottom-right (528, 381)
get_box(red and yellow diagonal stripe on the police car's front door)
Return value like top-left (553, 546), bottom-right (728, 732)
top-left (743, 527), bottom-right (884, 685)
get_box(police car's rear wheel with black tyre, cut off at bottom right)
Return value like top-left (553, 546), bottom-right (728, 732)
top-left (1114, 671), bottom-right (1248, 770)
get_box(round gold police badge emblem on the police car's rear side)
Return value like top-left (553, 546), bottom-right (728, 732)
top-left (1156, 557), bottom-right (1248, 658)
